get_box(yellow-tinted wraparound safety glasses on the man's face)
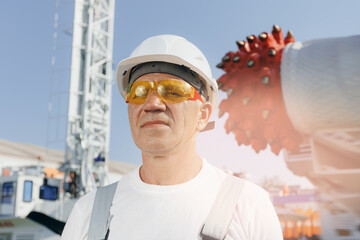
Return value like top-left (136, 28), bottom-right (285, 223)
top-left (126, 79), bottom-right (203, 104)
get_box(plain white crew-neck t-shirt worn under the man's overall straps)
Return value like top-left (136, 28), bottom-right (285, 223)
top-left (62, 161), bottom-right (283, 240)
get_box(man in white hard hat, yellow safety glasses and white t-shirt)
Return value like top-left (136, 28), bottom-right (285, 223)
top-left (62, 35), bottom-right (282, 240)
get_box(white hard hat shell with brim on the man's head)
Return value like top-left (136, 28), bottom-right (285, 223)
top-left (116, 35), bottom-right (219, 109)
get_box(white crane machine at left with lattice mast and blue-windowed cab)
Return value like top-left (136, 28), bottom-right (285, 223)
top-left (0, 0), bottom-right (115, 240)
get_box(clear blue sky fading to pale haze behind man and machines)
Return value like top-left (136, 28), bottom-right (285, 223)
top-left (0, 0), bottom-right (360, 186)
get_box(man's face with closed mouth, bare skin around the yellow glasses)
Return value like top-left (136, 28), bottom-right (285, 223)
top-left (128, 73), bottom-right (211, 153)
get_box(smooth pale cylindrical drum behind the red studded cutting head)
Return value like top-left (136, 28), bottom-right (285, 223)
top-left (281, 35), bottom-right (360, 134)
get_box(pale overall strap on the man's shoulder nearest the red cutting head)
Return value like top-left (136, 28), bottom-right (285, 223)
top-left (200, 175), bottom-right (245, 240)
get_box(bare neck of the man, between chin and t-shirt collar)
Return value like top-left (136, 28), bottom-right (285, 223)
top-left (139, 138), bottom-right (202, 185)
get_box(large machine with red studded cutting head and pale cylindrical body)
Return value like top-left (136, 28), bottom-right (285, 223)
top-left (217, 25), bottom-right (360, 239)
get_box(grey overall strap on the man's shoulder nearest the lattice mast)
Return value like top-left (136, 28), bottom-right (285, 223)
top-left (87, 182), bottom-right (118, 240)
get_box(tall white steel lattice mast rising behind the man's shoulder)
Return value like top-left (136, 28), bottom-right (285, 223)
top-left (65, 0), bottom-right (115, 197)
